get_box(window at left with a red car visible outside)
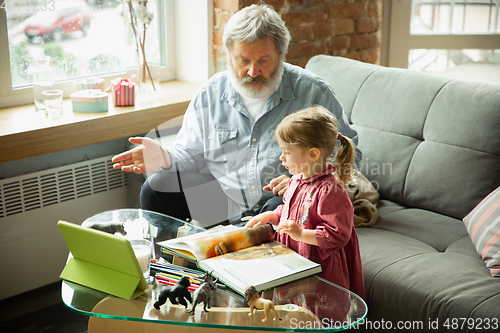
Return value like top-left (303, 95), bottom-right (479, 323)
top-left (0, 0), bottom-right (175, 107)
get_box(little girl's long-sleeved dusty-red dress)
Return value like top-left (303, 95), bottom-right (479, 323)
top-left (275, 164), bottom-right (365, 299)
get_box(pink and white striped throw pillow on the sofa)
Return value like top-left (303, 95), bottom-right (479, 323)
top-left (464, 187), bottom-right (500, 277)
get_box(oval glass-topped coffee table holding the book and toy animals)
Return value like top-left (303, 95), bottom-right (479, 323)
top-left (61, 209), bottom-right (367, 333)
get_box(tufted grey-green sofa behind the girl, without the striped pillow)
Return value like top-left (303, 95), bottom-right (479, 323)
top-left (306, 55), bottom-right (500, 332)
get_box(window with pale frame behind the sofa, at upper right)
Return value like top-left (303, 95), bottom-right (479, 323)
top-left (385, 0), bottom-right (500, 71)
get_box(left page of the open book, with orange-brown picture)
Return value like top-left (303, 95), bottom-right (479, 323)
top-left (158, 224), bottom-right (274, 261)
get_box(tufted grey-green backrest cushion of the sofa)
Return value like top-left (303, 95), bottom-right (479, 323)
top-left (306, 55), bottom-right (500, 219)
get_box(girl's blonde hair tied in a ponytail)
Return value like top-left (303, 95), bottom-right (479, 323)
top-left (275, 105), bottom-right (356, 185)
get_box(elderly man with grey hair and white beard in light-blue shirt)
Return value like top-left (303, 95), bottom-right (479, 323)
top-left (112, 5), bottom-right (360, 227)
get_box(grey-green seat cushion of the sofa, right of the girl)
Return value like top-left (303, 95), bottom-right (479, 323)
top-left (357, 200), bottom-right (500, 323)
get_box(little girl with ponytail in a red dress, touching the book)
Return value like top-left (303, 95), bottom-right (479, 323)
top-left (245, 106), bottom-right (365, 299)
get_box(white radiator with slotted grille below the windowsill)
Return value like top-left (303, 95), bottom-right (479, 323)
top-left (0, 156), bottom-right (127, 299)
